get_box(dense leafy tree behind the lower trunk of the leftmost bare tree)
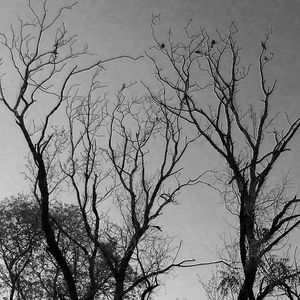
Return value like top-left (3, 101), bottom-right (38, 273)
top-left (0, 195), bottom-right (116, 300)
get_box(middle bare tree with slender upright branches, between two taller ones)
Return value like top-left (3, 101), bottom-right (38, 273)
top-left (64, 72), bottom-right (202, 299)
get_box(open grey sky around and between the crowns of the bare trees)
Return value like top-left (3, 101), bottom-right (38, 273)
top-left (0, 0), bottom-right (300, 300)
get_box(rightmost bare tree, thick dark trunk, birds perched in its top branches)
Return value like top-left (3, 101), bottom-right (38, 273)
top-left (147, 17), bottom-right (300, 300)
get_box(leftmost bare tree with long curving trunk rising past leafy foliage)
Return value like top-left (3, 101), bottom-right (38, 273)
top-left (0, 1), bottom-right (138, 300)
